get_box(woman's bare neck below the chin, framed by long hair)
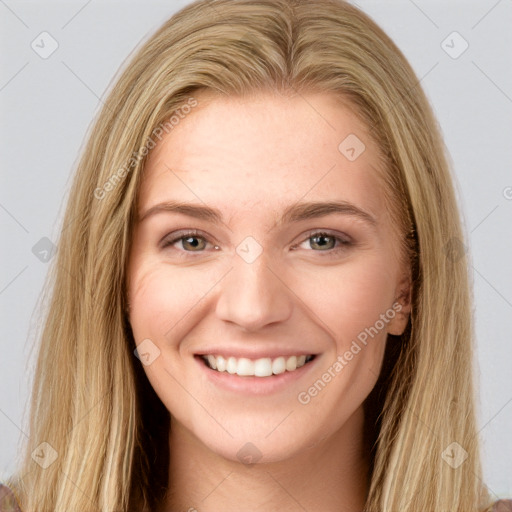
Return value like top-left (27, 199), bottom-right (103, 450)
top-left (161, 407), bottom-right (369, 512)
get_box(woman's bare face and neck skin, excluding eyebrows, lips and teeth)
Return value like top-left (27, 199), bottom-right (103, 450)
top-left (128, 92), bottom-right (410, 512)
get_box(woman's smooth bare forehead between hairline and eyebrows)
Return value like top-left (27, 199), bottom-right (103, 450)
top-left (139, 93), bottom-right (383, 223)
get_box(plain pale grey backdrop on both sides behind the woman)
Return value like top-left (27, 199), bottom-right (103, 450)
top-left (0, 0), bottom-right (512, 497)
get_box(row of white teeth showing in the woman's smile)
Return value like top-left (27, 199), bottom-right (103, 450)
top-left (202, 354), bottom-right (313, 377)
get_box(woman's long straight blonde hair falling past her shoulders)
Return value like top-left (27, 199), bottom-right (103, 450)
top-left (5, 0), bottom-right (489, 512)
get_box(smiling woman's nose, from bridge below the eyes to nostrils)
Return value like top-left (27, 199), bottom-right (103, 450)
top-left (216, 255), bottom-right (293, 331)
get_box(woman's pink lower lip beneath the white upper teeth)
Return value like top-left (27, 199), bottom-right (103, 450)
top-left (194, 354), bottom-right (319, 395)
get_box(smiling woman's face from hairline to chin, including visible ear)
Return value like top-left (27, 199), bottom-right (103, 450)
top-left (128, 93), bottom-right (409, 462)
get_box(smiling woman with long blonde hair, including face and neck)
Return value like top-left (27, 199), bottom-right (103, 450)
top-left (3, 0), bottom-right (510, 512)
